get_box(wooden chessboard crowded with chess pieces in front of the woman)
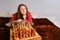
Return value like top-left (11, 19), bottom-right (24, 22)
top-left (10, 22), bottom-right (42, 40)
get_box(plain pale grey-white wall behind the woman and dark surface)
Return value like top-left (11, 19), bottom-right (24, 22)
top-left (0, 0), bottom-right (60, 28)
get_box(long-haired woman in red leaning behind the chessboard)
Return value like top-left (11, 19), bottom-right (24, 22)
top-left (9, 4), bottom-right (32, 23)
